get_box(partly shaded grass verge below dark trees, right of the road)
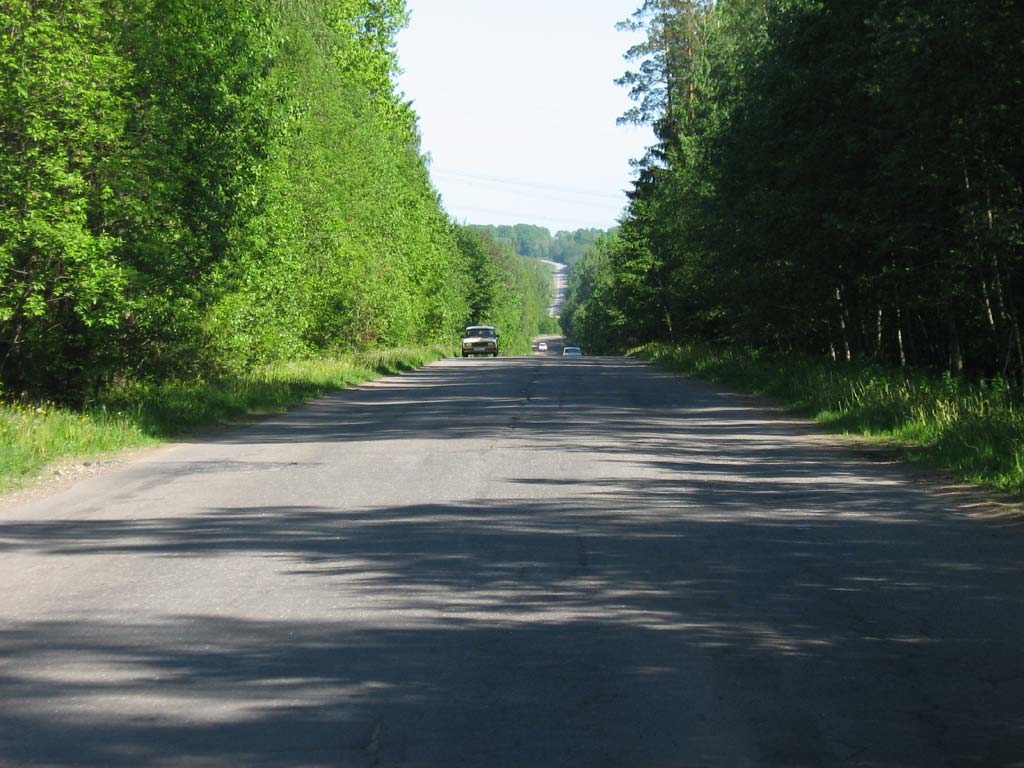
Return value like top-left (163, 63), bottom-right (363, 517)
top-left (630, 344), bottom-right (1024, 497)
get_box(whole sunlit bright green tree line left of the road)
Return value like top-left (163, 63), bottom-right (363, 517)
top-left (0, 0), bottom-right (550, 402)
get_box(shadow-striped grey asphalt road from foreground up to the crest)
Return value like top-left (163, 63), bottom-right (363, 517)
top-left (0, 356), bottom-right (1024, 768)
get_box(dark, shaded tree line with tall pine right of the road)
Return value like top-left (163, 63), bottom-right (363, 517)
top-left (562, 0), bottom-right (1024, 387)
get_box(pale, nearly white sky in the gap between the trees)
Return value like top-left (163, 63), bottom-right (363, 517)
top-left (397, 0), bottom-right (653, 231)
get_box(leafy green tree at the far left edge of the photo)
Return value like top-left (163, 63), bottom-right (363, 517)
top-left (0, 0), bottom-right (130, 394)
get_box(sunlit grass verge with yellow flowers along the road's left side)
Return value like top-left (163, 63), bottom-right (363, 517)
top-left (0, 347), bottom-right (449, 493)
